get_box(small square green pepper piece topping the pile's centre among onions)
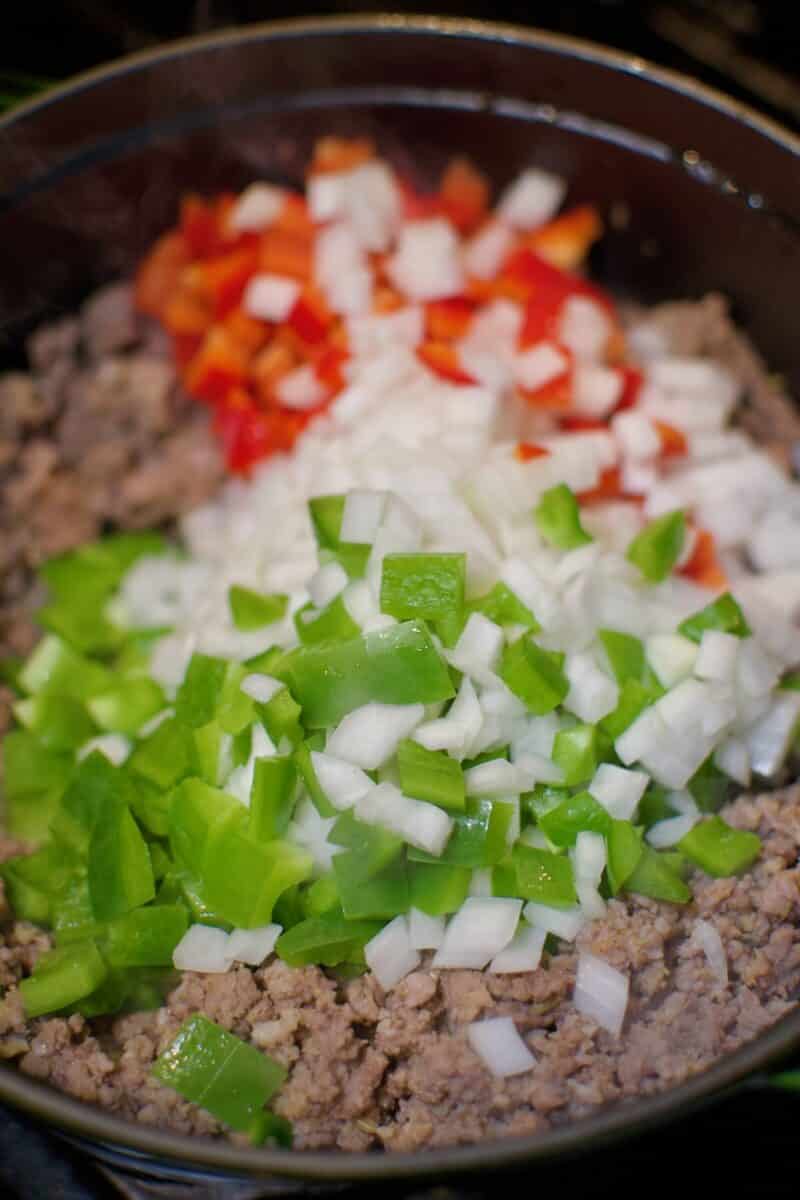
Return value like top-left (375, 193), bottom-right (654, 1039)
top-left (380, 553), bottom-right (467, 620)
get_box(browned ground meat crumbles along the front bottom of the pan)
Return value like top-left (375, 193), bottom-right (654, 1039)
top-left (0, 786), bottom-right (800, 1151)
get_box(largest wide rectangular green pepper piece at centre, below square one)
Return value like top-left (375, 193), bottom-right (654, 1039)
top-left (272, 620), bottom-right (455, 728)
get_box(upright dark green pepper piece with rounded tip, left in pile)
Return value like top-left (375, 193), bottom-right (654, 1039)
top-left (89, 805), bottom-right (156, 920)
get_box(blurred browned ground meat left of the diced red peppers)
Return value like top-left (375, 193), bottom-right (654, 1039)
top-left (0, 283), bottom-right (222, 672)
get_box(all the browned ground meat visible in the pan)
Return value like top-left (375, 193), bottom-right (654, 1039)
top-left (0, 286), bottom-right (800, 1151)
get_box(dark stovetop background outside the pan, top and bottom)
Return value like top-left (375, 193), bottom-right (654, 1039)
top-left (0, 0), bottom-right (800, 1200)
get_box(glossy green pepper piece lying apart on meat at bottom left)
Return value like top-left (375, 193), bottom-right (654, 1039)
top-left (151, 1013), bottom-right (287, 1133)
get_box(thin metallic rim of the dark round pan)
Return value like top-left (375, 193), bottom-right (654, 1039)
top-left (0, 16), bottom-right (800, 1183)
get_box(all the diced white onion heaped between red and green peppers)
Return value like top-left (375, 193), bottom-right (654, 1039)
top-left (118, 145), bottom-right (800, 1075)
